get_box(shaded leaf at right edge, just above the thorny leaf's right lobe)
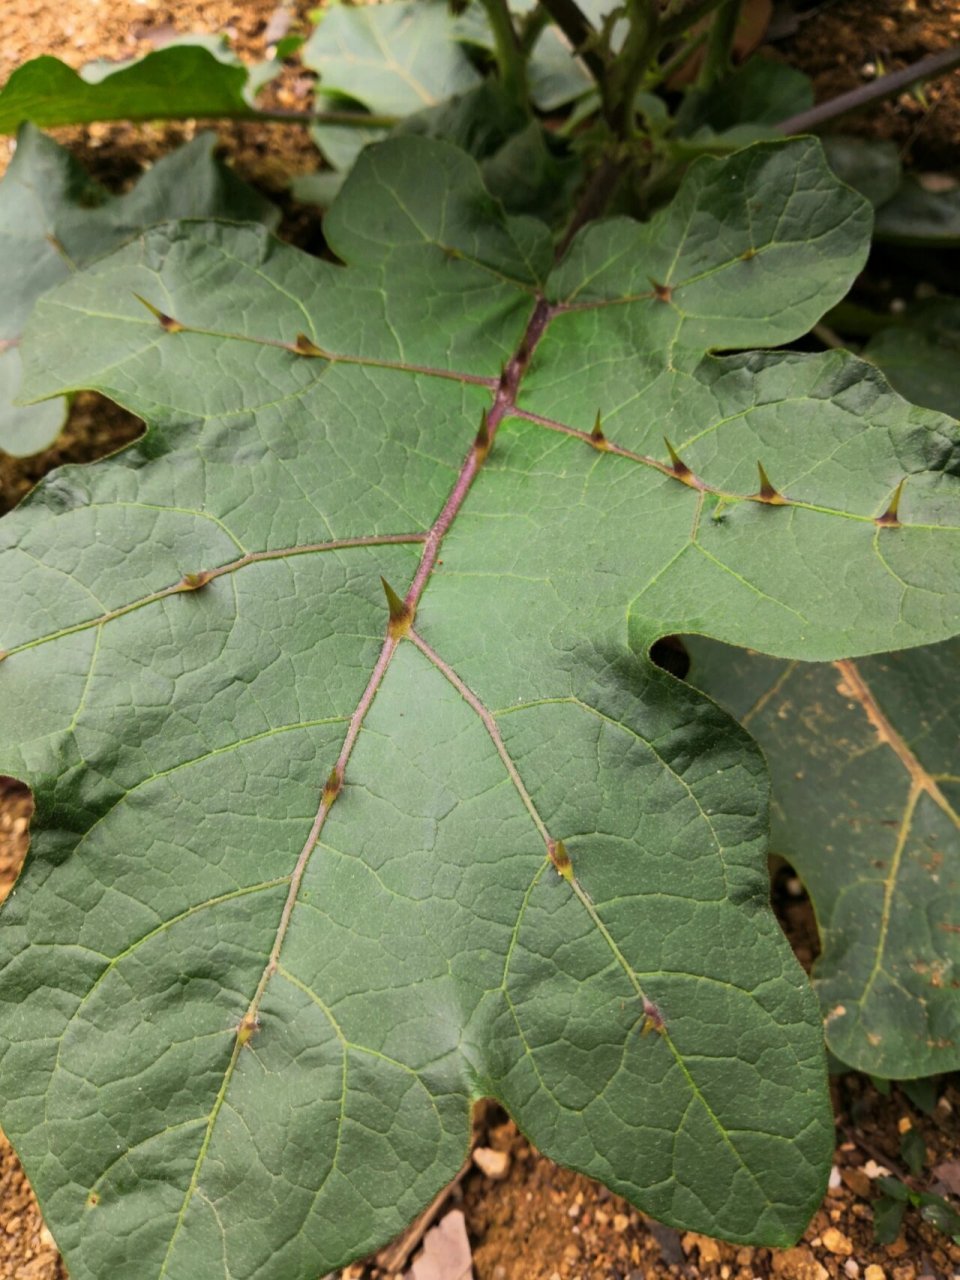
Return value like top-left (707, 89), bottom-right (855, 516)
top-left (863, 297), bottom-right (960, 417)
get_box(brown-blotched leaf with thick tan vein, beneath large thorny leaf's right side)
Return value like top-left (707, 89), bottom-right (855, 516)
top-left (691, 640), bottom-right (960, 1079)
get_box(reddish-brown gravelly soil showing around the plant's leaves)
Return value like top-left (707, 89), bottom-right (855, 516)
top-left (0, 0), bottom-right (960, 1280)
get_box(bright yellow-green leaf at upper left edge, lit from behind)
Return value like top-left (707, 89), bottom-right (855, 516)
top-left (0, 44), bottom-right (255, 133)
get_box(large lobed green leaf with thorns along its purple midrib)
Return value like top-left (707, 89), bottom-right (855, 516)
top-left (0, 138), bottom-right (960, 1280)
